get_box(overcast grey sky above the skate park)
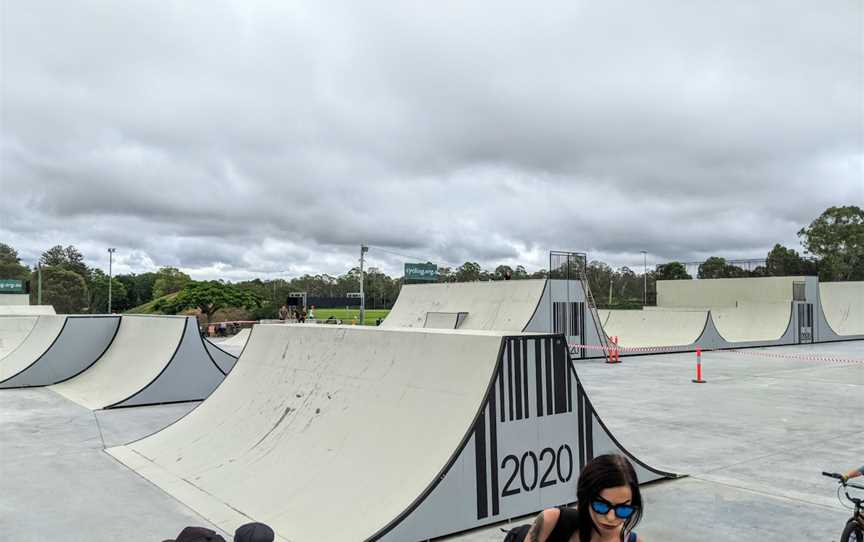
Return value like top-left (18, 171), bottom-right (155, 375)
top-left (0, 0), bottom-right (864, 280)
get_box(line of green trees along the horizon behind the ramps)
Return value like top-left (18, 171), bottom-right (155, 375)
top-left (0, 206), bottom-right (864, 314)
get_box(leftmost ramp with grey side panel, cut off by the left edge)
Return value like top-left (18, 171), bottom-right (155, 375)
top-left (0, 316), bottom-right (120, 388)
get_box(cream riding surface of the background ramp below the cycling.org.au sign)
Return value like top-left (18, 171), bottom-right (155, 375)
top-left (381, 279), bottom-right (546, 331)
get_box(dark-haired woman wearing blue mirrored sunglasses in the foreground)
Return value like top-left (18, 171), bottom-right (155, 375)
top-left (525, 455), bottom-right (644, 542)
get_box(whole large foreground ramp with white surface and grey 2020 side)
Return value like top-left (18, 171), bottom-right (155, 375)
top-left (107, 324), bottom-right (673, 542)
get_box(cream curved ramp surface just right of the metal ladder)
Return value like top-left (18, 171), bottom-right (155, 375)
top-left (598, 310), bottom-right (708, 348)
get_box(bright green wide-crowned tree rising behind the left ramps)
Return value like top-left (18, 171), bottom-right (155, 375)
top-left (154, 280), bottom-right (263, 323)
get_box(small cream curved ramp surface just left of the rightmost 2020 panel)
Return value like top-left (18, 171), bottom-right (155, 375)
top-left (711, 303), bottom-right (792, 342)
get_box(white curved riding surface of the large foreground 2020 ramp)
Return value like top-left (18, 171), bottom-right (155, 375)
top-left (109, 324), bottom-right (501, 540)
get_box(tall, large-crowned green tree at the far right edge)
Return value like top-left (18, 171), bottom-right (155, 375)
top-left (798, 205), bottom-right (864, 280)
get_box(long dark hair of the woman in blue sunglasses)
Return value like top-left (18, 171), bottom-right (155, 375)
top-left (576, 454), bottom-right (642, 542)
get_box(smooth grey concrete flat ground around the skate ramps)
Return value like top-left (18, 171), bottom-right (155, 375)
top-left (0, 341), bottom-right (864, 542)
